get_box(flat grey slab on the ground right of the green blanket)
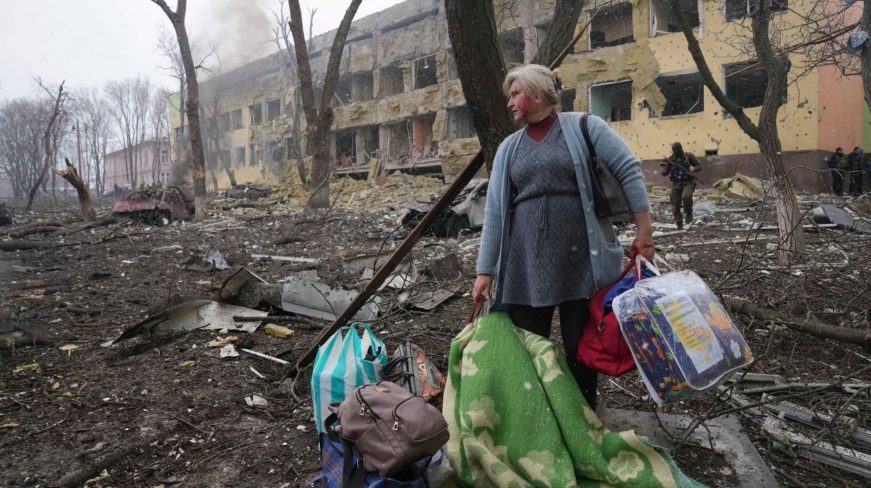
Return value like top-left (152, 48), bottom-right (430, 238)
top-left (598, 408), bottom-right (778, 488)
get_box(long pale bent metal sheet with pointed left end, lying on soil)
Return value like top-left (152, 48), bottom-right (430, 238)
top-left (102, 300), bottom-right (269, 347)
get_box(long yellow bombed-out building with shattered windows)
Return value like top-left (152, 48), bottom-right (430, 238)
top-left (172, 0), bottom-right (867, 191)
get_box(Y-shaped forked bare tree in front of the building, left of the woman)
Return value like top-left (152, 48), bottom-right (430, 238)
top-left (289, 0), bottom-right (362, 208)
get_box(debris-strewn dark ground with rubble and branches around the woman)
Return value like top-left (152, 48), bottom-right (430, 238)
top-left (0, 175), bottom-right (871, 487)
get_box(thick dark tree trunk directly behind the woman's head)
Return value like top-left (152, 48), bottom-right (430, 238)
top-left (445, 0), bottom-right (516, 170)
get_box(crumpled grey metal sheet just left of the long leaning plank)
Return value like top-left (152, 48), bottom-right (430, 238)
top-left (281, 270), bottom-right (378, 322)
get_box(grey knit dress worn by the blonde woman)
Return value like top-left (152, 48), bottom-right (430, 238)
top-left (502, 122), bottom-right (595, 307)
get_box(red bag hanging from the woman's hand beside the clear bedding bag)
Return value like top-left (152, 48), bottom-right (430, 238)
top-left (577, 255), bottom-right (656, 376)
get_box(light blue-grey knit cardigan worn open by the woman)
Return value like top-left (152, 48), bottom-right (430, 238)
top-left (477, 112), bottom-right (650, 305)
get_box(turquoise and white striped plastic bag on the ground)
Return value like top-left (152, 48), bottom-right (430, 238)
top-left (312, 322), bottom-right (387, 433)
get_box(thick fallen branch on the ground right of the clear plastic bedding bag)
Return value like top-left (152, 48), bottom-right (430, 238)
top-left (723, 297), bottom-right (871, 351)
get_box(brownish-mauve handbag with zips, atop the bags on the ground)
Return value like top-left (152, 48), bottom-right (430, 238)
top-left (338, 381), bottom-right (448, 477)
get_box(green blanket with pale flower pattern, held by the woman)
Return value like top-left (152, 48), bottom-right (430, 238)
top-left (443, 312), bottom-right (704, 488)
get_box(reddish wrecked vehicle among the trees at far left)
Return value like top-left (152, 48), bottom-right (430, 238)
top-left (112, 185), bottom-right (194, 224)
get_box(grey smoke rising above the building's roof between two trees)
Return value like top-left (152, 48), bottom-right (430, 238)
top-left (188, 0), bottom-right (274, 72)
